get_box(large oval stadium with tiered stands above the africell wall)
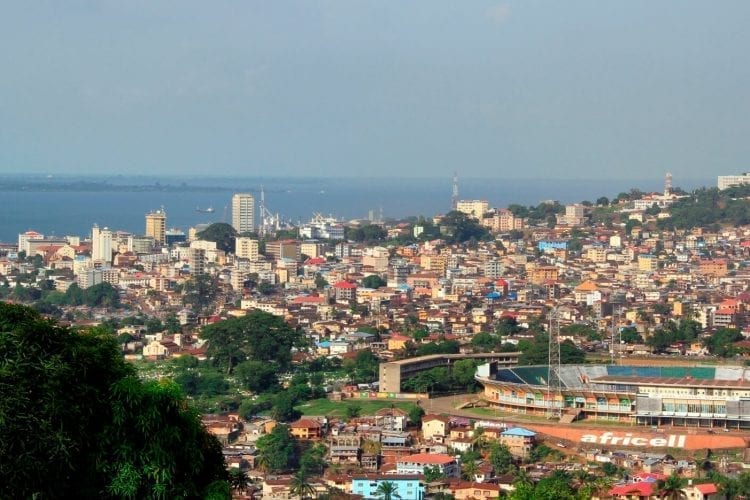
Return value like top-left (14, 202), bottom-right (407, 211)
top-left (476, 362), bottom-right (750, 430)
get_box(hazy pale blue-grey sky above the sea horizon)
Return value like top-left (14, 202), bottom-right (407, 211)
top-left (0, 0), bottom-right (750, 183)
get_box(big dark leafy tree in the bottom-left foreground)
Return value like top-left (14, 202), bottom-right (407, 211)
top-left (0, 303), bottom-right (229, 498)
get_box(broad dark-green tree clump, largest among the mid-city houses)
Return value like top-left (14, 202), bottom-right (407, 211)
top-left (200, 311), bottom-right (300, 373)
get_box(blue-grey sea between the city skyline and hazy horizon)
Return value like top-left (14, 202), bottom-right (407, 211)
top-left (0, 176), bottom-right (715, 242)
